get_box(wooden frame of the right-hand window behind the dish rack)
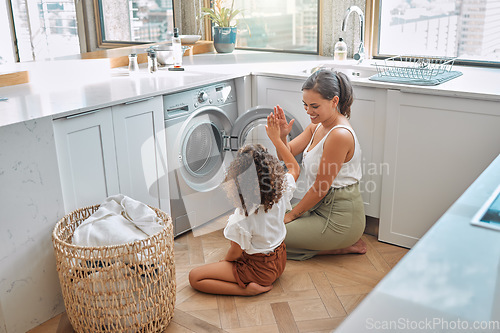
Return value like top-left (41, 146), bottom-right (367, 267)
top-left (365, 0), bottom-right (500, 68)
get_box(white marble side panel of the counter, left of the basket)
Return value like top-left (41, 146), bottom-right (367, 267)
top-left (0, 117), bottom-right (64, 332)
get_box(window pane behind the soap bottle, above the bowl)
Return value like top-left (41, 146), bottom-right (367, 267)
top-left (95, 0), bottom-right (174, 46)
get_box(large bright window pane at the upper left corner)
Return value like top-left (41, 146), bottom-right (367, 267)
top-left (11, 0), bottom-right (80, 62)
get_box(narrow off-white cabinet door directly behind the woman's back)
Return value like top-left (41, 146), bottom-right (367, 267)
top-left (350, 86), bottom-right (388, 218)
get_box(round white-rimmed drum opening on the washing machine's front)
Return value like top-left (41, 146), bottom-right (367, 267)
top-left (175, 106), bottom-right (232, 192)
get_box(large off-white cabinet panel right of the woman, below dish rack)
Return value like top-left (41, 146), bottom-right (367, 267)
top-left (379, 90), bottom-right (500, 247)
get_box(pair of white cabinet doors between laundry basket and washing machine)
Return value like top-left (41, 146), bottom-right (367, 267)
top-left (54, 97), bottom-right (170, 212)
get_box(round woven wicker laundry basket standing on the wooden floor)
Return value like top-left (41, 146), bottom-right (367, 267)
top-left (52, 205), bottom-right (176, 332)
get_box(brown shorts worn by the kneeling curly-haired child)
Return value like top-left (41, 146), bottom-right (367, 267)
top-left (233, 242), bottom-right (286, 288)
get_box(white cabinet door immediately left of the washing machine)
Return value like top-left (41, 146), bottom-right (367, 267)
top-left (112, 97), bottom-right (170, 213)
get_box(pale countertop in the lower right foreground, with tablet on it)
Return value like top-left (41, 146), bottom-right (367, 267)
top-left (336, 155), bottom-right (500, 332)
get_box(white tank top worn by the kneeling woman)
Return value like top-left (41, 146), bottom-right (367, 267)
top-left (302, 124), bottom-right (362, 189)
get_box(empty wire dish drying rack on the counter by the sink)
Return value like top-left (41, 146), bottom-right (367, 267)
top-left (375, 55), bottom-right (456, 80)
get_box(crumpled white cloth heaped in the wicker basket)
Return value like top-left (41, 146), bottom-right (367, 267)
top-left (73, 194), bottom-right (164, 246)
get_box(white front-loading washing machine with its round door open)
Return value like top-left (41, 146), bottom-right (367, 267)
top-left (163, 80), bottom-right (302, 236)
